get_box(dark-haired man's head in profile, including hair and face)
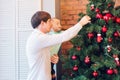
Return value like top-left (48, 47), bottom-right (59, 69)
top-left (31, 11), bottom-right (52, 33)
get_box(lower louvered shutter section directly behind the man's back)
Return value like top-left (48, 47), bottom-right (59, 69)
top-left (18, 31), bottom-right (31, 80)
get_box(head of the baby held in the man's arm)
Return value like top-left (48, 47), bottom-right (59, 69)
top-left (52, 18), bottom-right (62, 32)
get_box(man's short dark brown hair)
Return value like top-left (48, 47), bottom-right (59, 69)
top-left (31, 11), bottom-right (51, 28)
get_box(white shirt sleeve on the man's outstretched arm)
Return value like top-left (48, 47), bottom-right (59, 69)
top-left (37, 23), bottom-right (82, 48)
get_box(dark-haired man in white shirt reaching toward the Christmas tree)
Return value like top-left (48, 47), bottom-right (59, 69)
top-left (26, 11), bottom-right (90, 80)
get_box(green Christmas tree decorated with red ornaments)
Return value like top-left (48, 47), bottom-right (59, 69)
top-left (61, 0), bottom-right (120, 80)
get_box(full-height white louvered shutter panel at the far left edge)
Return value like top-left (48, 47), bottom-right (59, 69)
top-left (0, 0), bottom-right (15, 80)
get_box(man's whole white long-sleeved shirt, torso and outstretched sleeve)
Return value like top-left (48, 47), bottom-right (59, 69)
top-left (26, 23), bottom-right (82, 80)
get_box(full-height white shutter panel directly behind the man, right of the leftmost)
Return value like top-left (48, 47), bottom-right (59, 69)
top-left (16, 0), bottom-right (41, 80)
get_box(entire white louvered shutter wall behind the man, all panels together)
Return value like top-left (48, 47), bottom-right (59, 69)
top-left (0, 0), bottom-right (41, 80)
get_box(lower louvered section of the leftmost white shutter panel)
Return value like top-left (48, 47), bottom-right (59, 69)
top-left (0, 29), bottom-right (15, 80)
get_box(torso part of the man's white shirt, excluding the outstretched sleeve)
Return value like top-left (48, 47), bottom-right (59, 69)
top-left (26, 30), bottom-right (51, 80)
